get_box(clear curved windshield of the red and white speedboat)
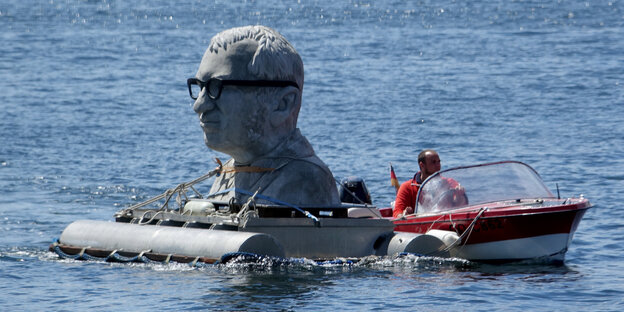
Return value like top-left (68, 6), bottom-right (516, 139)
top-left (416, 161), bottom-right (554, 214)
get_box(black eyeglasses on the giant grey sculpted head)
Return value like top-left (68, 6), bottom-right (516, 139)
top-left (186, 78), bottom-right (299, 100)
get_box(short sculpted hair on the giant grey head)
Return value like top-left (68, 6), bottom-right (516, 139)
top-left (208, 26), bottom-right (303, 92)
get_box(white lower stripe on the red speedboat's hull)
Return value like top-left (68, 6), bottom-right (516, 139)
top-left (450, 234), bottom-right (571, 260)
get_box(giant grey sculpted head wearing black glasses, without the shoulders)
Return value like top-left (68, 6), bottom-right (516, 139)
top-left (189, 26), bottom-right (303, 164)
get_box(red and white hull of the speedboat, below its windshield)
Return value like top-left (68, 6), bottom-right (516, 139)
top-left (394, 199), bottom-right (591, 262)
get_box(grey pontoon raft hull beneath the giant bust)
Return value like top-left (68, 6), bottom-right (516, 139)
top-left (50, 213), bottom-right (410, 263)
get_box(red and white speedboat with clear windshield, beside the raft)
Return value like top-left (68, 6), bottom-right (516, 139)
top-left (381, 161), bottom-right (591, 262)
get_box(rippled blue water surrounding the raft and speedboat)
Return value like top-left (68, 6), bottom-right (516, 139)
top-left (0, 0), bottom-right (624, 311)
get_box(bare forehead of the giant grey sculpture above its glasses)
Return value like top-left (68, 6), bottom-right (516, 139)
top-left (197, 39), bottom-right (258, 81)
